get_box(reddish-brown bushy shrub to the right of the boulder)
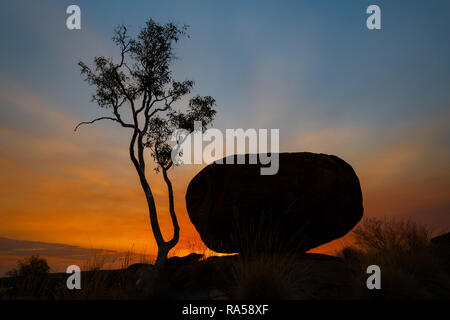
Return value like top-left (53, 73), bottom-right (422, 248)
top-left (341, 219), bottom-right (450, 299)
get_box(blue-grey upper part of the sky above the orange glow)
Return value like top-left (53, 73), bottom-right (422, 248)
top-left (0, 1), bottom-right (450, 127)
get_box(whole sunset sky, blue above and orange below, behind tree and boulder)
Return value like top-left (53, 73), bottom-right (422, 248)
top-left (0, 0), bottom-right (450, 272)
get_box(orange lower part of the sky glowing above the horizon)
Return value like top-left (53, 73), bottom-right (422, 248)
top-left (0, 81), bottom-right (450, 254)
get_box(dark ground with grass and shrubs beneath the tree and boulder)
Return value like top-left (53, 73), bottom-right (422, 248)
top-left (0, 221), bottom-right (450, 300)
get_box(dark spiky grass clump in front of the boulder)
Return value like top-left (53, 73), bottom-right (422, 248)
top-left (232, 212), bottom-right (307, 300)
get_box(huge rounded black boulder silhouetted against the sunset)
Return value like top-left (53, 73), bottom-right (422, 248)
top-left (186, 152), bottom-right (363, 253)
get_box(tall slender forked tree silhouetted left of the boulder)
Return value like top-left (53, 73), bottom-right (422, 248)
top-left (75, 19), bottom-right (216, 268)
